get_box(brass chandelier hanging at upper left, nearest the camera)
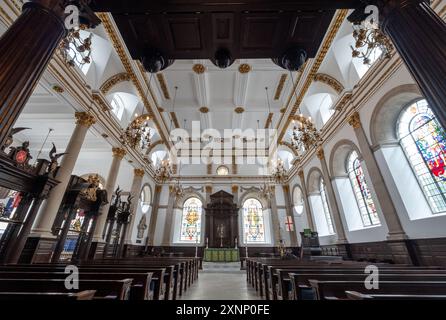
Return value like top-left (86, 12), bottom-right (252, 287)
top-left (58, 24), bottom-right (93, 69)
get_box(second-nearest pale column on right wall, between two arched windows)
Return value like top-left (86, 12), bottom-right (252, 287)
top-left (317, 148), bottom-right (347, 243)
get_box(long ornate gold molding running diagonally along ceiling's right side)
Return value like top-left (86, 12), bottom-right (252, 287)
top-left (279, 9), bottom-right (348, 140)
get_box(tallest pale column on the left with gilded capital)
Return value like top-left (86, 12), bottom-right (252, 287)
top-left (31, 112), bottom-right (96, 237)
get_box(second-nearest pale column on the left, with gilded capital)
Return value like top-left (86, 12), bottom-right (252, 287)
top-left (93, 148), bottom-right (127, 242)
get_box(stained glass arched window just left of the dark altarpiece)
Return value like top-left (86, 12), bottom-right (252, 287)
top-left (180, 198), bottom-right (203, 243)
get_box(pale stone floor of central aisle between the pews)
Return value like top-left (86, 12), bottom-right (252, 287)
top-left (180, 262), bottom-right (259, 300)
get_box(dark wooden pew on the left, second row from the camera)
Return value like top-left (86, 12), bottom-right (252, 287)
top-left (0, 279), bottom-right (132, 300)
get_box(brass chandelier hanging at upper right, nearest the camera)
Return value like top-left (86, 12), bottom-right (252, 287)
top-left (350, 21), bottom-right (393, 65)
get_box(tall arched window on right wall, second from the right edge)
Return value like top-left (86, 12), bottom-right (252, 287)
top-left (347, 151), bottom-right (380, 227)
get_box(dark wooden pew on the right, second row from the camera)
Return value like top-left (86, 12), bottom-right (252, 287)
top-left (309, 280), bottom-right (446, 300)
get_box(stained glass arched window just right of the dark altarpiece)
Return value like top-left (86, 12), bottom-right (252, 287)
top-left (243, 198), bottom-right (265, 243)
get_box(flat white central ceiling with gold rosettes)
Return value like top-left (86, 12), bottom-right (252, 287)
top-left (152, 59), bottom-right (294, 134)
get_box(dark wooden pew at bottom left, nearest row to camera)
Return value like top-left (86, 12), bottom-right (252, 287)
top-left (0, 290), bottom-right (96, 301)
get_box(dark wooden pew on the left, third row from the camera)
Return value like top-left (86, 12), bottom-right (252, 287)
top-left (0, 271), bottom-right (153, 300)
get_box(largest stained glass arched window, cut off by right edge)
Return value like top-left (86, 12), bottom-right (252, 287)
top-left (398, 100), bottom-right (446, 213)
